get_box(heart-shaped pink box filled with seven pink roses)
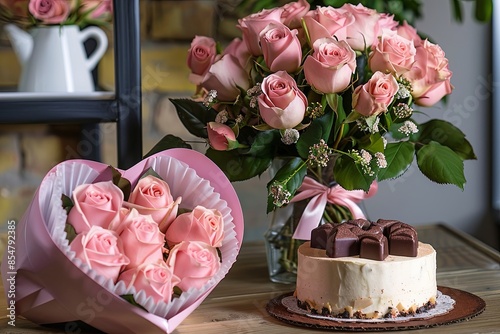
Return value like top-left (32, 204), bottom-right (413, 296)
top-left (2, 149), bottom-right (243, 333)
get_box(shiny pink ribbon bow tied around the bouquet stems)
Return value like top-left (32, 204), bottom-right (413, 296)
top-left (291, 176), bottom-right (378, 240)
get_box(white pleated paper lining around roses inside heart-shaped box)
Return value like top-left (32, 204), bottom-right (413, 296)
top-left (39, 156), bottom-right (238, 319)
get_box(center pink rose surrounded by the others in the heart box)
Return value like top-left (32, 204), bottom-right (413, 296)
top-left (116, 209), bottom-right (165, 269)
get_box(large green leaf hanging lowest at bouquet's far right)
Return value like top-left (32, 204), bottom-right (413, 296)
top-left (417, 141), bottom-right (465, 190)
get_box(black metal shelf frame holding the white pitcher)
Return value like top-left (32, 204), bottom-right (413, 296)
top-left (0, 0), bottom-right (142, 169)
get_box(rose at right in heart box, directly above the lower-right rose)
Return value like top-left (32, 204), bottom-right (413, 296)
top-left (165, 205), bottom-right (224, 247)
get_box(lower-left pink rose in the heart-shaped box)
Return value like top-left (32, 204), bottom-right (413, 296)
top-left (69, 226), bottom-right (130, 283)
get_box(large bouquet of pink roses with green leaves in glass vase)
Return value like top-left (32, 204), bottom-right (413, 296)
top-left (167, 0), bottom-right (475, 232)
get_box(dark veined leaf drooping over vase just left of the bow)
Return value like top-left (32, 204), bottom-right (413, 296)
top-left (267, 157), bottom-right (307, 213)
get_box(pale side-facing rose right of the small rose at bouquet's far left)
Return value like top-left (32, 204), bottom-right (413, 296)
top-left (201, 54), bottom-right (250, 102)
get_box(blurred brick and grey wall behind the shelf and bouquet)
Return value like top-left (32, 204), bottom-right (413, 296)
top-left (0, 0), bottom-right (500, 248)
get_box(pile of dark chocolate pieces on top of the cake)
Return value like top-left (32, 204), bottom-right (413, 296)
top-left (311, 219), bottom-right (418, 261)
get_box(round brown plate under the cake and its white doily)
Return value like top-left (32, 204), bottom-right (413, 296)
top-left (266, 286), bottom-right (486, 332)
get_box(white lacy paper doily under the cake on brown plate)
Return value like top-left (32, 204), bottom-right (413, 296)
top-left (281, 291), bottom-right (455, 323)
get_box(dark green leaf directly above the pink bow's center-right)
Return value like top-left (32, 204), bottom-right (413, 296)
top-left (333, 155), bottom-right (376, 191)
